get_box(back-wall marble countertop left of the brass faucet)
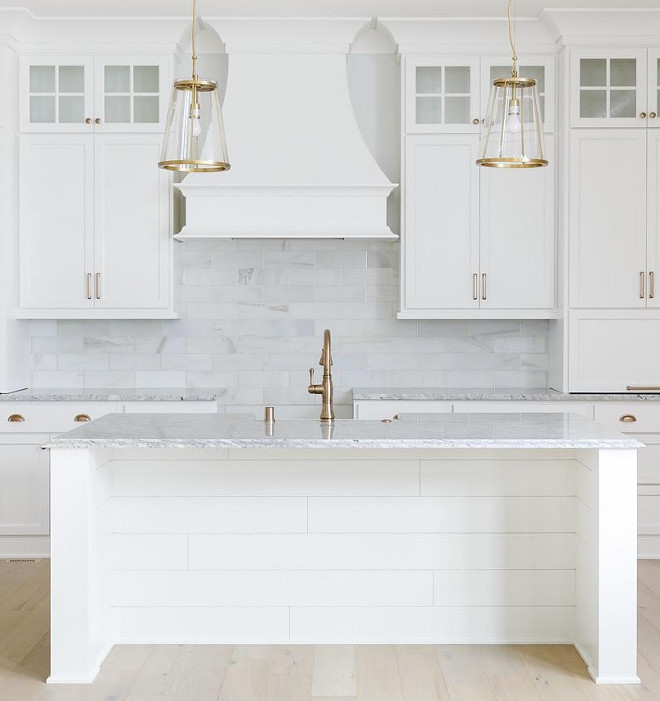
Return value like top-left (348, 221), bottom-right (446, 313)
top-left (0, 388), bottom-right (220, 402)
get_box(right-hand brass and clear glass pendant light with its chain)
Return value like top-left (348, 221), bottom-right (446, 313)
top-left (477, 0), bottom-right (548, 168)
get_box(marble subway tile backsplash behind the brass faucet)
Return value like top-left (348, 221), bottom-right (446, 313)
top-left (30, 240), bottom-right (548, 417)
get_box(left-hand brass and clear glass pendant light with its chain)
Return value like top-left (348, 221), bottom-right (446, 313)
top-left (158, 0), bottom-right (231, 173)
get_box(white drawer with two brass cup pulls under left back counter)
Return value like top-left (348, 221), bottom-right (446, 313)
top-left (0, 402), bottom-right (117, 434)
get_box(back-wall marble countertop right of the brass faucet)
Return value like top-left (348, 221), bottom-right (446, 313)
top-left (353, 387), bottom-right (660, 402)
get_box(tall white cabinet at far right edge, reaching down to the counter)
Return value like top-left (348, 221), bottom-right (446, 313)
top-left (568, 49), bottom-right (660, 392)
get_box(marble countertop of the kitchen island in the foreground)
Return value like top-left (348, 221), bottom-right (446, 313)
top-left (46, 413), bottom-right (643, 449)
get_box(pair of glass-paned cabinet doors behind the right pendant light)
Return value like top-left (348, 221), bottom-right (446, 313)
top-left (404, 56), bottom-right (555, 134)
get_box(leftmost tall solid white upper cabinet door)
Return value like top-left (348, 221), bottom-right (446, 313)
top-left (20, 134), bottom-right (93, 309)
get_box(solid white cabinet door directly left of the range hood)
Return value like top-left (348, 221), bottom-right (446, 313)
top-left (94, 134), bottom-right (171, 309)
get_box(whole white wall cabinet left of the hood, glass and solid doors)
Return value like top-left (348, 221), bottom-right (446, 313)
top-left (18, 54), bottom-right (176, 319)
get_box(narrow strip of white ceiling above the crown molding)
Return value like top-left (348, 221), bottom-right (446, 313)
top-left (0, 0), bottom-right (660, 17)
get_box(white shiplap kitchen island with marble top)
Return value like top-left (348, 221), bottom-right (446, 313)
top-left (49, 414), bottom-right (642, 683)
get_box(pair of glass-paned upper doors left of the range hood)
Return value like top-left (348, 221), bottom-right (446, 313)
top-left (20, 54), bottom-right (171, 133)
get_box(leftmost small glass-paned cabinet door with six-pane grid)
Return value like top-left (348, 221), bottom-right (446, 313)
top-left (20, 54), bottom-right (94, 133)
